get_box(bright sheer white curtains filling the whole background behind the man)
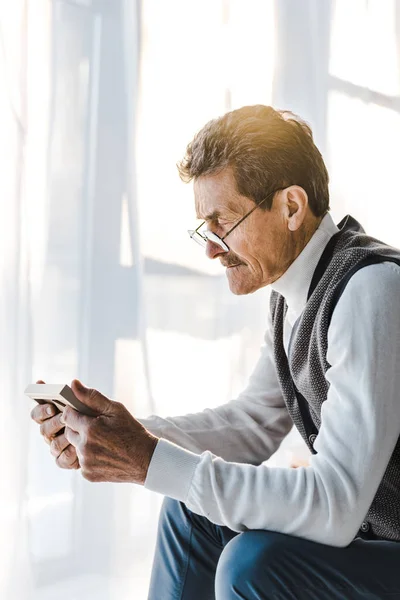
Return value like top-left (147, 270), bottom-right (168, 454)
top-left (0, 0), bottom-right (400, 600)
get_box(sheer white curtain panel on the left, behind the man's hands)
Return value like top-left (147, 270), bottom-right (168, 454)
top-left (0, 0), bottom-right (153, 600)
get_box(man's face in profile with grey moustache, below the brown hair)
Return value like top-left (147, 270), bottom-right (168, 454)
top-left (194, 169), bottom-right (307, 294)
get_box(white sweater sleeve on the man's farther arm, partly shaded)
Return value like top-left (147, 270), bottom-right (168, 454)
top-left (138, 319), bottom-right (292, 465)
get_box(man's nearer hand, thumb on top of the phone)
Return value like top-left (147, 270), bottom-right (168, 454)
top-left (62, 379), bottom-right (158, 485)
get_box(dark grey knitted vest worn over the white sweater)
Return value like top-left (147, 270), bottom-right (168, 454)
top-left (270, 215), bottom-right (400, 541)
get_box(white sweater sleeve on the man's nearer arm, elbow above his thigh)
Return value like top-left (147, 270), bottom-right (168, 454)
top-left (145, 263), bottom-right (400, 546)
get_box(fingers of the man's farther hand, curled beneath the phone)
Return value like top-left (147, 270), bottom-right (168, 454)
top-left (31, 380), bottom-right (80, 469)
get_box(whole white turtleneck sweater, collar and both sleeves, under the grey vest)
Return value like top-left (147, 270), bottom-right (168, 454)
top-left (140, 213), bottom-right (400, 546)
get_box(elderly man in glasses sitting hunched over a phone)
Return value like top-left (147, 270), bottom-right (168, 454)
top-left (32, 106), bottom-right (400, 600)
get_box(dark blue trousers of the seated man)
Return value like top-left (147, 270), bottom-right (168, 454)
top-left (148, 498), bottom-right (400, 600)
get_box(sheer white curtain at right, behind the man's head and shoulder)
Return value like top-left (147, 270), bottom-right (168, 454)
top-left (274, 0), bottom-right (400, 246)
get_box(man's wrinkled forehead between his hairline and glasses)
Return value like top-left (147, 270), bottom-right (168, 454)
top-left (193, 170), bottom-right (243, 221)
